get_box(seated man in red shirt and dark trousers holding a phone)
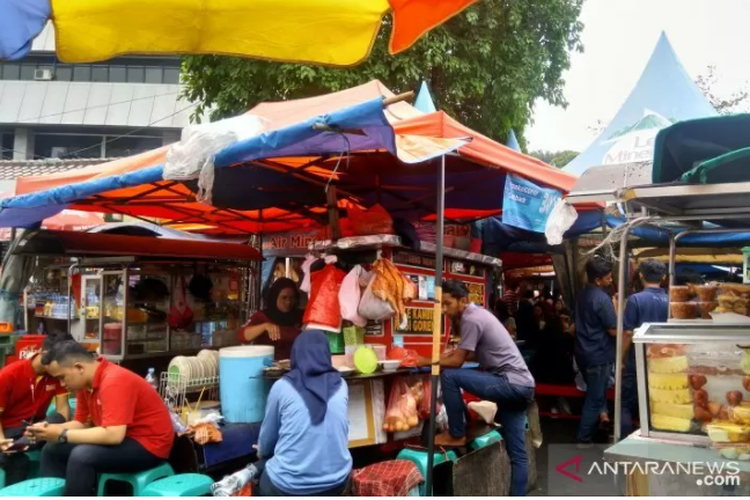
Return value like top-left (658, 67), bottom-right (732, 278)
top-left (28, 341), bottom-right (174, 496)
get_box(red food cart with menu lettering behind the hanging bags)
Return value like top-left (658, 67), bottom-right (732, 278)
top-left (263, 233), bottom-right (502, 448)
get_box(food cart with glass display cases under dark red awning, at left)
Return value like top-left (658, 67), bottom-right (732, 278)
top-left (8, 231), bottom-right (261, 372)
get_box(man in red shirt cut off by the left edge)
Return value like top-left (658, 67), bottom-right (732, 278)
top-left (0, 333), bottom-right (72, 485)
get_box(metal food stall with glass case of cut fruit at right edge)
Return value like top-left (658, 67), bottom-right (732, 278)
top-left (571, 114), bottom-right (750, 496)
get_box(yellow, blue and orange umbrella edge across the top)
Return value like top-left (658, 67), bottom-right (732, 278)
top-left (0, 0), bottom-right (477, 66)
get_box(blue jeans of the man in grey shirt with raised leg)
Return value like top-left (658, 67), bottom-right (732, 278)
top-left (440, 369), bottom-right (534, 496)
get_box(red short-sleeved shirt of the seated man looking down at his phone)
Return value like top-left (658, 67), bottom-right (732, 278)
top-left (75, 358), bottom-right (174, 459)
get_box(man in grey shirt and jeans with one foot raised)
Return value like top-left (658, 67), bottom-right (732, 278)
top-left (420, 280), bottom-right (534, 496)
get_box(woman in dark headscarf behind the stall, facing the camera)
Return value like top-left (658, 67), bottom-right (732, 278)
top-left (239, 278), bottom-right (302, 360)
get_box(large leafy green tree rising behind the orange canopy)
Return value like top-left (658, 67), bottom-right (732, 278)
top-left (182, 0), bottom-right (583, 145)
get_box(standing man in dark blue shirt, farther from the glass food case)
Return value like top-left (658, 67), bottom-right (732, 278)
top-left (575, 256), bottom-right (617, 446)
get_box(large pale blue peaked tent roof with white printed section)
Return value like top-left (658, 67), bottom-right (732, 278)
top-left (565, 33), bottom-right (717, 175)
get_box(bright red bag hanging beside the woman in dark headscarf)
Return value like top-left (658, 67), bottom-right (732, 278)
top-left (302, 264), bottom-right (346, 333)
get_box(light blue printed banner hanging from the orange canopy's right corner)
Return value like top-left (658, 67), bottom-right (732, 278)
top-left (503, 174), bottom-right (562, 233)
